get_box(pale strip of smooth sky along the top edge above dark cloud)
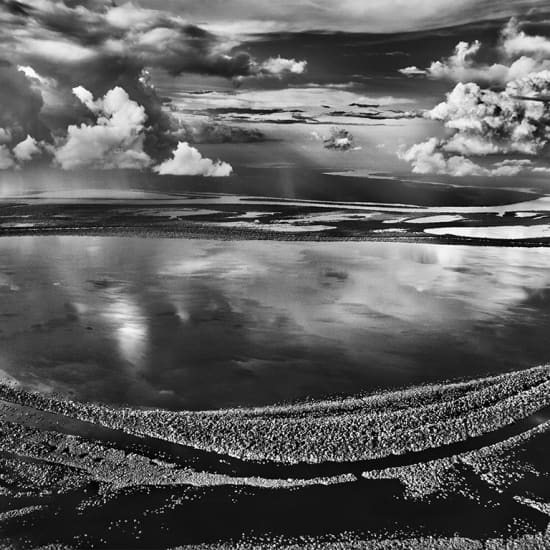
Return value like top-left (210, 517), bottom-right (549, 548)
top-left (138, 0), bottom-right (547, 33)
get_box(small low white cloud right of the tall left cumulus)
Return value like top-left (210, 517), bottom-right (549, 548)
top-left (153, 141), bottom-right (233, 178)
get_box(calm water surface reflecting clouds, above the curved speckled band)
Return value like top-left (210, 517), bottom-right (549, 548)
top-left (0, 237), bottom-right (550, 408)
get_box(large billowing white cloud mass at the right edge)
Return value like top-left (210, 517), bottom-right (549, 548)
top-left (400, 30), bottom-right (550, 176)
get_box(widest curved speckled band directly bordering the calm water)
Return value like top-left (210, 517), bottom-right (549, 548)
top-left (0, 365), bottom-right (550, 464)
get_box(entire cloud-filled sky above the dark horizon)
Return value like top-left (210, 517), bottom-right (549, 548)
top-left (0, 0), bottom-right (550, 182)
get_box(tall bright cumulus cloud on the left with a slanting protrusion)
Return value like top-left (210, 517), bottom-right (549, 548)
top-left (55, 86), bottom-right (152, 170)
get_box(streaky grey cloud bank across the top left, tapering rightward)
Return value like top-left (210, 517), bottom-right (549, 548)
top-left (0, 0), bottom-right (306, 82)
